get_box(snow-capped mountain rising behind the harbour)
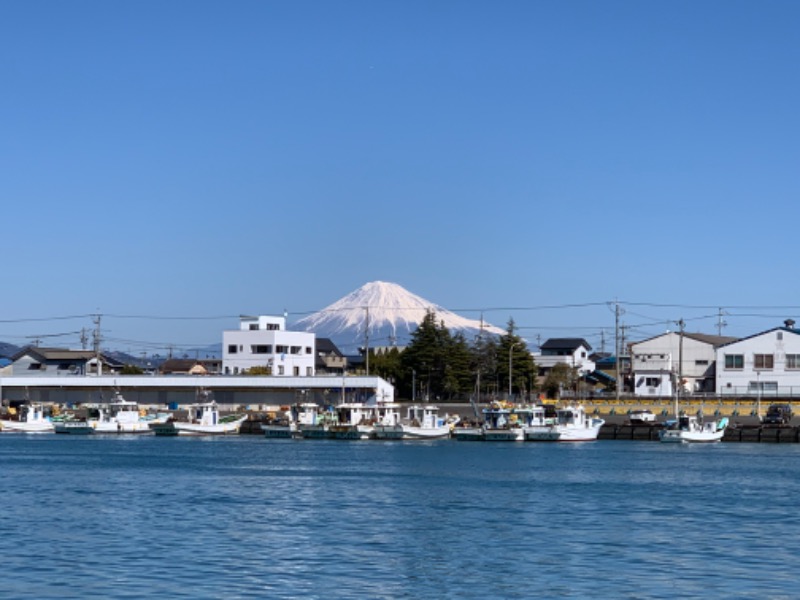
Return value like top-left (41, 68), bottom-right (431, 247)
top-left (292, 281), bottom-right (505, 354)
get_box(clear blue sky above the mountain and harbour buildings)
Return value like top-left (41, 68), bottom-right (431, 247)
top-left (0, 0), bottom-right (800, 352)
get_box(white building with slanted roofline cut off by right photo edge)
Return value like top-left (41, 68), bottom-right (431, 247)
top-left (716, 319), bottom-right (800, 396)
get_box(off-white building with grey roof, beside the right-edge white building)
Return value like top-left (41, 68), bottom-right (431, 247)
top-left (630, 331), bottom-right (736, 396)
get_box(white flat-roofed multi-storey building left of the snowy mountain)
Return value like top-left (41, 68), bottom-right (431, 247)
top-left (222, 316), bottom-right (316, 377)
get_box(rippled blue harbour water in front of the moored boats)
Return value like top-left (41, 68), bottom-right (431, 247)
top-left (0, 434), bottom-right (800, 598)
